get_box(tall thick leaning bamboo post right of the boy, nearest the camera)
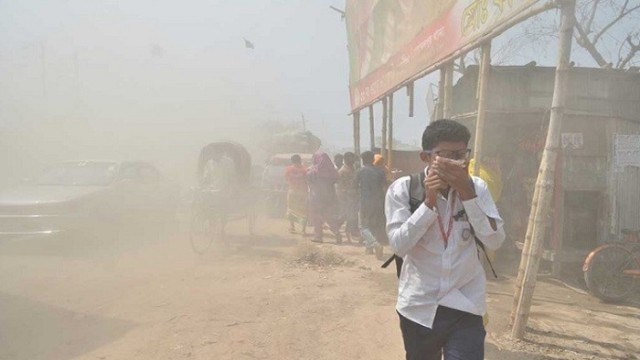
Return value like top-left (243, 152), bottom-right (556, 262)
top-left (511, 0), bottom-right (576, 339)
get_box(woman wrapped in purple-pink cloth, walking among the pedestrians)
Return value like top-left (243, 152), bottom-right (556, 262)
top-left (307, 151), bottom-right (342, 244)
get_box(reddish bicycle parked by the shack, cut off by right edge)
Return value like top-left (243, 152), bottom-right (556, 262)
top-left (582, 229), bottom-right (640, 302)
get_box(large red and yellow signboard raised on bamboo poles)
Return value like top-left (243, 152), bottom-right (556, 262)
top-left (346, 0), bottom-right (539, 110)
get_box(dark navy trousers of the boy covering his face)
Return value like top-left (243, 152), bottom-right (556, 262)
top-left (398, 306), bottom-right (486, 360)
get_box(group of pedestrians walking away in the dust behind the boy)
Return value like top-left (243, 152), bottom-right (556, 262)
top-left (285, 151), bottom-right (391, 258)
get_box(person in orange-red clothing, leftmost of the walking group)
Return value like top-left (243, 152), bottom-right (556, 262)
top-left (284, 154), bottom-right (309, 235)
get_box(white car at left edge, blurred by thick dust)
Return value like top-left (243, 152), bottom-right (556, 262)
top-left (0, 161), bottom-right (178, 237)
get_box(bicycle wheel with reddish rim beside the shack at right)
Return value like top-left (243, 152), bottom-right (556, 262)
top-left (584, 245), bottom-right (637, 302)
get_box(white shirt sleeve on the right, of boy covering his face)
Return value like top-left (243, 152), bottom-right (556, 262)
top-left (462, 177), bottom-right (505, 250)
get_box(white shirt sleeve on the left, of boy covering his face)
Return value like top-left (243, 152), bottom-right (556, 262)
top-left (385, 177), bottom-right (437, 257)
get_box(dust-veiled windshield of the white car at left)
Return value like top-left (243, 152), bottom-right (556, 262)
top-left (35, 162), bottom-right (117, 186)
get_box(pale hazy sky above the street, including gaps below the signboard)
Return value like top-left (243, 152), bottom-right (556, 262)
top-left (0, 0), bottom-right (636, 181)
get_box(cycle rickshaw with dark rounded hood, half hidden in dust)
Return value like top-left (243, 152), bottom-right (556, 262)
top-left (190, 142), bottom-right (256, 254)
